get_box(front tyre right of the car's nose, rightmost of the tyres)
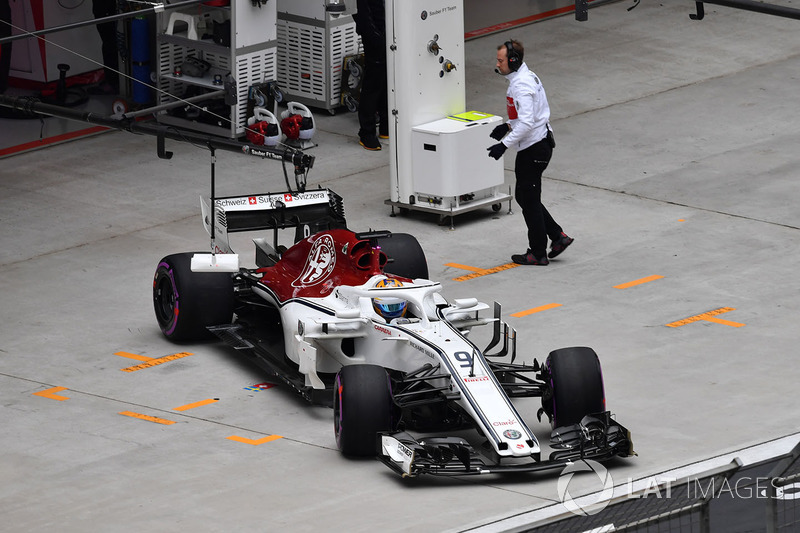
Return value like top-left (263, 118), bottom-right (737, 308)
top-left (542, 347), bottom-right (606, 428)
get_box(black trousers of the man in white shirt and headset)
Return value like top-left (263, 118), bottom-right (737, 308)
top-left (514, 139), bottom-right (562, 258)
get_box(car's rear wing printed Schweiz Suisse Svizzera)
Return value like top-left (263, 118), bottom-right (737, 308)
top-left (200, 189), bottom-right (346, 253)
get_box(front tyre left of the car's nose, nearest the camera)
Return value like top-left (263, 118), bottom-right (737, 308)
top-left (333, 365), bottom-right (394, 456)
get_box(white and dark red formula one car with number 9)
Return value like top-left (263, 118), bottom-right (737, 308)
top-left (153, 189), bottom-right (634, 477)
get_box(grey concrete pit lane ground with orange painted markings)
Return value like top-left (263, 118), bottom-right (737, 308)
top-left (0, 1), bottom-right (800, 532)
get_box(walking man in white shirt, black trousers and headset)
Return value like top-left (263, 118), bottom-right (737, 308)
top-left (487, 40), bottom-right (574, 266)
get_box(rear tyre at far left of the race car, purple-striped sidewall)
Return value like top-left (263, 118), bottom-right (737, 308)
top-left (153, 252), bottom-right (234, 341)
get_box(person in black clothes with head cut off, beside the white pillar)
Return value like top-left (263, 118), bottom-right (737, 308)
top-left (353, 0), bottom-right (389, 151)
